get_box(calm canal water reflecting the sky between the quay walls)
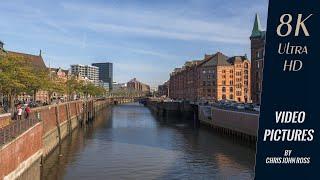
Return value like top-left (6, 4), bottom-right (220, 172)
top-left (41, 103), bottom-right (255, 180)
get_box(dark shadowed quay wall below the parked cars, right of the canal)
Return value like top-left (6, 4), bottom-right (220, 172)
top-left (146, 99), bottom-right (259, 142)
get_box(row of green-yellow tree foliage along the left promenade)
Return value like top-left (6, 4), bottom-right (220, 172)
top-left (0, 53), bottom-right (106, 108)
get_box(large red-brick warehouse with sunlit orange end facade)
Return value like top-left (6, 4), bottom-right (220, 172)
top-left (169, 52), bottom-right (251, 102)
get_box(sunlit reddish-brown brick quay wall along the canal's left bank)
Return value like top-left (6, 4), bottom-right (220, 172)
top-left (0, 98), bottom-right (133, 180)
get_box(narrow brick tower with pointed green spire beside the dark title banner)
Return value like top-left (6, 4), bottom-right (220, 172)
top-left (250, 14), bottom-right (266, 104)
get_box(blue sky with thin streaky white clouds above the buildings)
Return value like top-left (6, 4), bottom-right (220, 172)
top-left (0, 0), bottom-right (268, 87)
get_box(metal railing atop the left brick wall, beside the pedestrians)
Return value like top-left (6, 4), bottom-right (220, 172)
top-left (0, 118), bottom-right (40, 146)
